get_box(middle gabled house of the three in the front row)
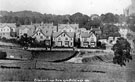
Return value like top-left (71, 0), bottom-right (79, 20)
top-left (53, 31), bottom-right (75, 47)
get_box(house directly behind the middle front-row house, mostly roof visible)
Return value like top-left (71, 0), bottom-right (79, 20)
top-left (58, 24), bottom-right (79, 32)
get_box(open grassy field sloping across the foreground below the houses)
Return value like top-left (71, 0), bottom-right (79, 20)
top-left (0, 48), bottom-right (135, 82)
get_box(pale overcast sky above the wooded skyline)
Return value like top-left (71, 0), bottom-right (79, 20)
top-left (0, 0), bottom-right (131, 15)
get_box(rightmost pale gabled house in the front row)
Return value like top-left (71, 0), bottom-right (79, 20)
top-left (80, 32), bottom-right (97, 47)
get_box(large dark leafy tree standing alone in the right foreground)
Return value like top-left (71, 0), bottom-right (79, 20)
top-left (112, 38), bottom-right (132, 66)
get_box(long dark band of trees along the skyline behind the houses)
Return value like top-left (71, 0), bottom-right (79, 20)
top-left (0, 11), bottom-right (125, 29)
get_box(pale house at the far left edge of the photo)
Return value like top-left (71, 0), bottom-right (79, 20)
top-left (0, 23), bottom-right (16, 39)
